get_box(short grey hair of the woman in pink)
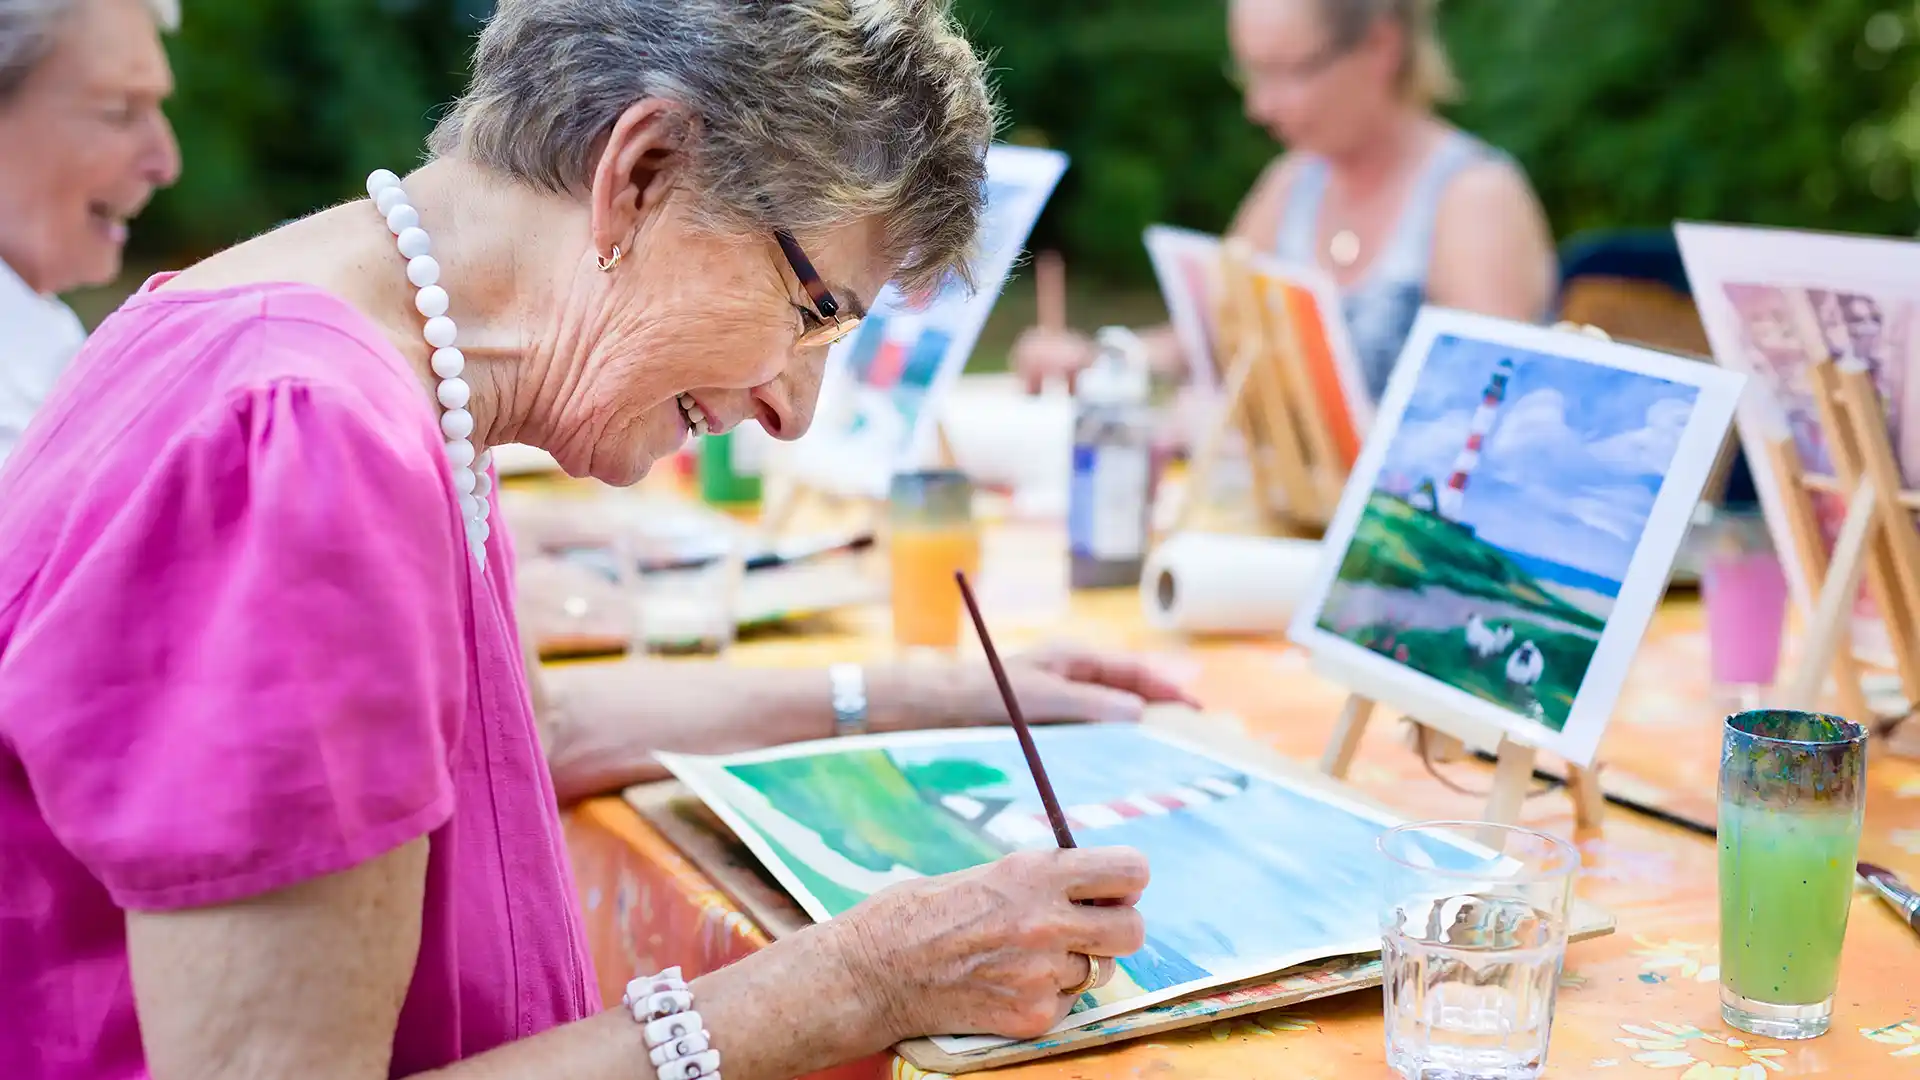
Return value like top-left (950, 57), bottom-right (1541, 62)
top-left (433, 0), bottom-right (996, 292)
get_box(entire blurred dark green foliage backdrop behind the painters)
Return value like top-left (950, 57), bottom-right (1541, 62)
top-left (138, 0), bottom-right (1920, 282)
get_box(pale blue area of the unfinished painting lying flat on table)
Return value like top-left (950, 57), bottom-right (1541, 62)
top-left (891, 726), bottom-right (1467, 990)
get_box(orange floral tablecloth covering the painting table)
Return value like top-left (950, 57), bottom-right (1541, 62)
top-left (568, 528), bottom-right (1920, 1080)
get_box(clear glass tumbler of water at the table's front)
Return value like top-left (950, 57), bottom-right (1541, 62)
top-left (1379, 821), bottom-right (1580, 1080)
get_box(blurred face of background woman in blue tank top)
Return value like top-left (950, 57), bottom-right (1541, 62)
top-left (1227, 0), bottom-right (1404, 156)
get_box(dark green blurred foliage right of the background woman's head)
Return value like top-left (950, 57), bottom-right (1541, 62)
top-left (1446, 0), bottom-right (1920, 234)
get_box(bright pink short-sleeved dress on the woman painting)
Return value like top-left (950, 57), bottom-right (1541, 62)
top-left (0, 279), bottom-right (599, 1080)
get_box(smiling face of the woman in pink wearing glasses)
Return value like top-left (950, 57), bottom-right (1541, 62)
top-left (543, 192), bottom-right (891, 484)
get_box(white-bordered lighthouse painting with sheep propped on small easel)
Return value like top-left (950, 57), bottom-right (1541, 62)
top-left (1290, 307), bottom-right (1745, 765)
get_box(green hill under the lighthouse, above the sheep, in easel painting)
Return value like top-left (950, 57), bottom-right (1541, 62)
top-left (1340, 492), bottom-right (1607, 634)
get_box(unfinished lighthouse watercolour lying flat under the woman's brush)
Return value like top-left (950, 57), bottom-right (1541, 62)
top-left (660, 724), bottom-right (1478, 1053)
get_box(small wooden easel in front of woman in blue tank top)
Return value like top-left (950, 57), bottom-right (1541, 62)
top-left (1173, 240), bottom-right (1348, 534)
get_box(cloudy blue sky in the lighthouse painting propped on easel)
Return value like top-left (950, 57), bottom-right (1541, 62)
top-left (1380, 334), bottom-right (1697, 580)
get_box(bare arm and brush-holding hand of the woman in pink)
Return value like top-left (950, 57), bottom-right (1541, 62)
top-left (127, 838), bottom-right (1148, 1080)
